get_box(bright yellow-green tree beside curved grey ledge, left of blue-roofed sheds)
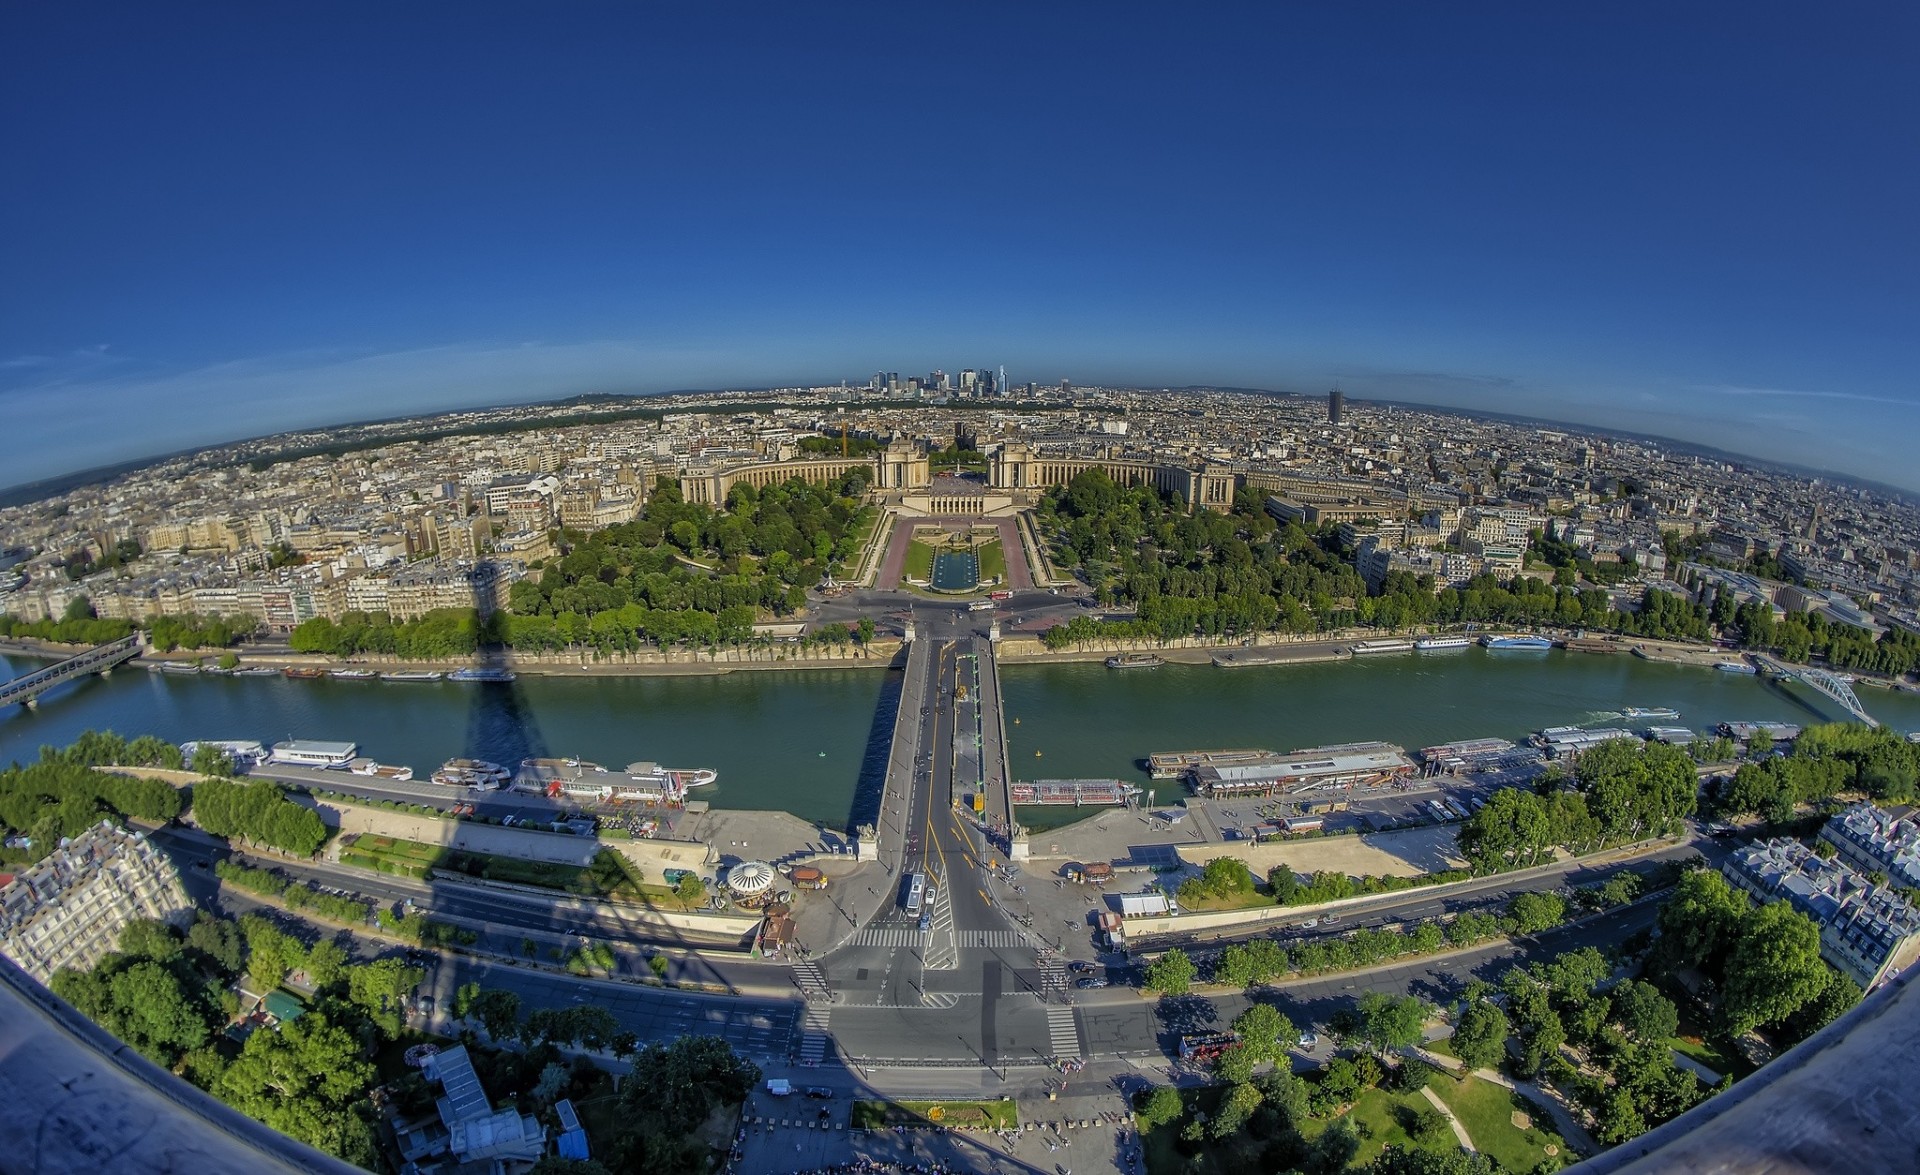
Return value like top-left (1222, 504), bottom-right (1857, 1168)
top-left (213, 1012), bottom-right (374, 1163)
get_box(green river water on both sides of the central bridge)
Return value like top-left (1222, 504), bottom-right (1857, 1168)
top-left (0, 649), bottom-right (1920, 826)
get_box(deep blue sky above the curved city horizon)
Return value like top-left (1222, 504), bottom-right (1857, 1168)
top-left (0, 2), bottom-right (1920, 490)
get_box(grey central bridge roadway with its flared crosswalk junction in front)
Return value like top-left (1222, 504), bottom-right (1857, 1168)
top-left (814, 605), bottom-right (1079, 1071)
